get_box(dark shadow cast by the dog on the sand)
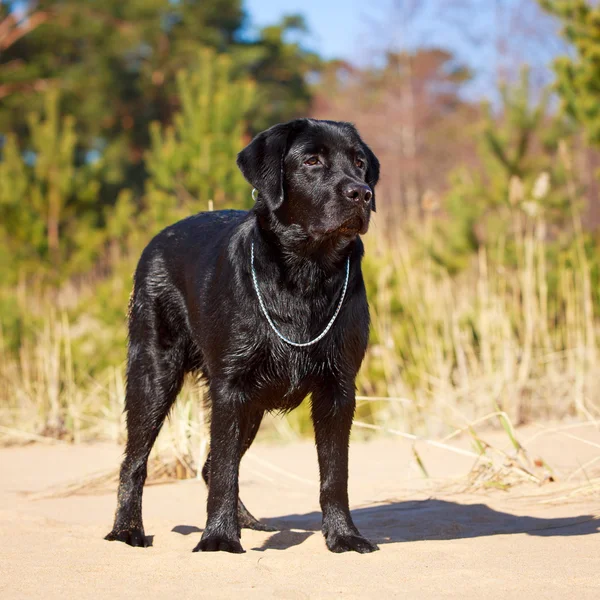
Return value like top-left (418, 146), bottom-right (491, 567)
top-left (173, 499), bottom-right (600, 551)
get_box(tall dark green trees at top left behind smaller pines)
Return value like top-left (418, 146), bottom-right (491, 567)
top-left (0, 0), bottom-right (316, 205)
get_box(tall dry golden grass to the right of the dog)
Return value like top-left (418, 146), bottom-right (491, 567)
top-left (360, 204), bottom-right (600, 435)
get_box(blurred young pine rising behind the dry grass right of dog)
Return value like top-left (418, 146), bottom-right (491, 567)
top-left (433, 68), bottom-right (571, 270)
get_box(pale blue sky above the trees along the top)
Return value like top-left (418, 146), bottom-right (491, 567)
top-left (245, 0), bottom-right (564, 97)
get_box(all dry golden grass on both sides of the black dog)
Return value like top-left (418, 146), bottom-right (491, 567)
top-left (0, 188), bottom-right (600, 487)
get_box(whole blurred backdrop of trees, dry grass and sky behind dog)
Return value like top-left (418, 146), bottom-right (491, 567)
top-left (0, 0), bottom-right (600, 472)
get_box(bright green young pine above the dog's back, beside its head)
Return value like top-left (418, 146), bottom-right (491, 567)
top-left (146, 49), bottom-right (257, 219)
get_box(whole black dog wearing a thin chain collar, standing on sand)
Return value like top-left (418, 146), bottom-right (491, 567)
top-left (106, 119), bottom-right (379, 552)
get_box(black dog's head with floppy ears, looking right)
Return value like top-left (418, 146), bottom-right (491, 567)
top-left (237, 119), bottom-right (379, 241)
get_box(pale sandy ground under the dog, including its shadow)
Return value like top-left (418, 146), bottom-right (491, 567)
top-left (0, 427), bottom-right (600, 600)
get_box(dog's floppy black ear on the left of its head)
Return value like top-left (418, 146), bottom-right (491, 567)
top-left (237, 122), bottom-right (293, 211)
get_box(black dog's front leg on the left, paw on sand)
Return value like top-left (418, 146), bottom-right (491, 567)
top-left (194, 381), bottom-right (245, 553)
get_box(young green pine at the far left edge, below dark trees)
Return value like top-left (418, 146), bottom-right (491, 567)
top-left (0, 91), bottom-right (101, 280)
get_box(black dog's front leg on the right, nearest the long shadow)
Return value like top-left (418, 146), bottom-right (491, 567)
top-left (312, 389), bottom-right (378, 554)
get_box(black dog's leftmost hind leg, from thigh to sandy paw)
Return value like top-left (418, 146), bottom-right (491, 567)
top-left (105, 302), bottom-right (185, 547)
